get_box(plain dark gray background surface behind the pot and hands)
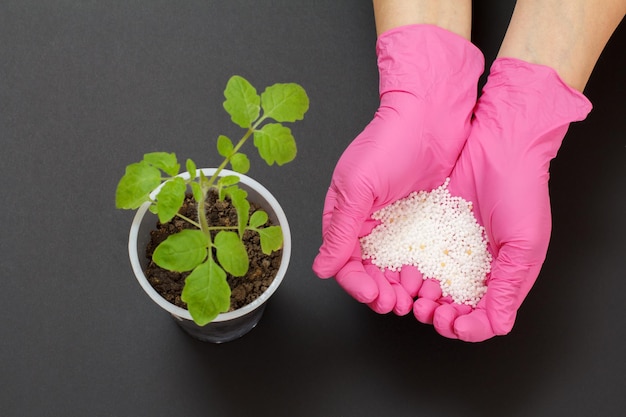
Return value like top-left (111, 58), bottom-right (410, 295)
top-left (0, 0), bottom-right (626, 417)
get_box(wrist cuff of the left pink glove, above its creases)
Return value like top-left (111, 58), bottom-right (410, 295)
top-left (376, 24), bottom-right (485, 97)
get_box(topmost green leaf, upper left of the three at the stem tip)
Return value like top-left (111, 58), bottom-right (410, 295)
top-left (224, 75), bottom-right (261, 128)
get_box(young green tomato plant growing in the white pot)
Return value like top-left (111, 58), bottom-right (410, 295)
top-left (115, 76), bottom-right (309, 326)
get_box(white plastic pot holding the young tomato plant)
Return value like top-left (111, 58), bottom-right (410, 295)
top-left (128, 168), bottom-right (291, 343)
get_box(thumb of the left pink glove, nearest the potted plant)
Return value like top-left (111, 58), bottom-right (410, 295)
top-left (313, 186), bottom-right (371, 278)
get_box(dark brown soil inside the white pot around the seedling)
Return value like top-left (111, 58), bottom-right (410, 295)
top-left (145, 193), bottom-right (282, 311)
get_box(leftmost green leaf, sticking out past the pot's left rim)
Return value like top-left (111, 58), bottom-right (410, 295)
top-left (115, 161), bottom-right (161, 210)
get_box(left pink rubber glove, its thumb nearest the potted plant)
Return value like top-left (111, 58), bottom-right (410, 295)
top-left (313, 25), bottom-right (484, 314)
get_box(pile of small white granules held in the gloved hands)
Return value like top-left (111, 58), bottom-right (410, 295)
top-left (360, 179), bottom-right (492, 307)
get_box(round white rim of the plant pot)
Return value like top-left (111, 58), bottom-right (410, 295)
top-left (128, 168), bottom-right (291, 324)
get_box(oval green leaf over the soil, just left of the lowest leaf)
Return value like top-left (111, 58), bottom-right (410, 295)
top-left (152, 229), bottom-right (208, 272)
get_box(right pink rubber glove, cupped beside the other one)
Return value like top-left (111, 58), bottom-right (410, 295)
top-left (414, 58), bottom-right (591, 342)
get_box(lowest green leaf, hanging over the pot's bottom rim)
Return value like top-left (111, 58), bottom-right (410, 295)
top-left (180, 258), bottom-right (230, 326)
